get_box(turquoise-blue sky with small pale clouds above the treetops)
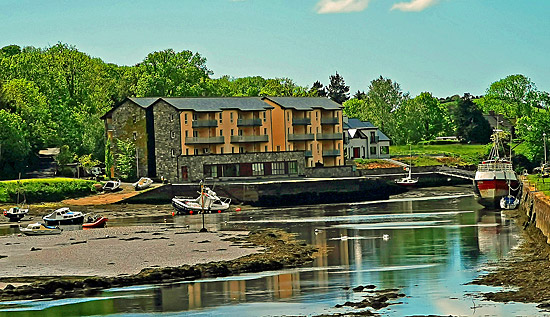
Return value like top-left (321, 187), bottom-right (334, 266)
top-left (0, 0), bottom-right (550, 97)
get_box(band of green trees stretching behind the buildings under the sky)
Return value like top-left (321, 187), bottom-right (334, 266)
top-left (0, 43), bottom-right (550, 178)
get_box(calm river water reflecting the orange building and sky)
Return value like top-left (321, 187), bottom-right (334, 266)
top-left (0, 186), bottom-right (542, 316)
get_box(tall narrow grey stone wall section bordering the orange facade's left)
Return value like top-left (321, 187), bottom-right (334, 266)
top-left (153, 100), bottom-right (181, 182)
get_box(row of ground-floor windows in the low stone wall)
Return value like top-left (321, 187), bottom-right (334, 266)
top-left (203, 161), bottom-right (298, 178)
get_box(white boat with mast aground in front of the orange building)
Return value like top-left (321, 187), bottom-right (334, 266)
top-left (172, 184), bottom-right (231, 214)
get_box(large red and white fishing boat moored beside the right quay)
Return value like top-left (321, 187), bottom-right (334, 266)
top-left (474, 129), bottom-right (520, 208)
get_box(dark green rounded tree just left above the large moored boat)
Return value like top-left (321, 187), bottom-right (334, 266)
top-left (452, 94), bottom-right (492, 144)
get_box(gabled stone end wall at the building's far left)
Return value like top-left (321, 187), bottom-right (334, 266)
top-left (107, 101), bottom-right (149, 176)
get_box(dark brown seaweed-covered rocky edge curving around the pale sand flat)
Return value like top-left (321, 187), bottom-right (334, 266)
top-left (0, 229), bottom-right (317, 301)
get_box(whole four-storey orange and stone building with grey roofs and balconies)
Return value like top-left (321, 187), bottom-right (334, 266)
top-left (102, 97), bottom-right (344, 181)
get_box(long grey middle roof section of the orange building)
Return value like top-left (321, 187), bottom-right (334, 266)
top-left (160, 97), bottom-right (273, 112)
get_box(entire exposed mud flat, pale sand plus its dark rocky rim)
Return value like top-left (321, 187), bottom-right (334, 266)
top-left (0, 226), bottom-right (316, 301)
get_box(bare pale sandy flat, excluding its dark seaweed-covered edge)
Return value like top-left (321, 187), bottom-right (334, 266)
top-left (0, 225), bottom-right (260, 278)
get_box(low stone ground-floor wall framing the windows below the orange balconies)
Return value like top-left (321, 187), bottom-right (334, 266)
top-left (176, 151), bottom-right (306, 181)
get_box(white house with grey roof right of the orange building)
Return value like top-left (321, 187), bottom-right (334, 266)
top-left (343, 117), bottom-right (390, 159)
